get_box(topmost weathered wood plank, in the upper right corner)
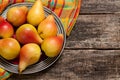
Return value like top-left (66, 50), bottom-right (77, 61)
top-left (80, 0), bottom-right (120, 14)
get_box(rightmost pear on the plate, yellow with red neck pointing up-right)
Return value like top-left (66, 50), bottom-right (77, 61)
top-left (41, 34), bottom-right (64, 57)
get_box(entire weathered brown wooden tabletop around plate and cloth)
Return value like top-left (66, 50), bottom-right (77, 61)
top-left (8, 0), bottom-right (120, 80)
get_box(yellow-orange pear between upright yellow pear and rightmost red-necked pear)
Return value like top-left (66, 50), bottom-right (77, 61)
top-left (38, 15), bottom-right (58, 39)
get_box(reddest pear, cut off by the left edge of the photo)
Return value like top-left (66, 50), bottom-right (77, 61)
top-left (0, 18), bottom-right (14, 38)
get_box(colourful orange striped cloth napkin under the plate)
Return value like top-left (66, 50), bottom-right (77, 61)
top-left (0, 0), bottom-right (81, 80)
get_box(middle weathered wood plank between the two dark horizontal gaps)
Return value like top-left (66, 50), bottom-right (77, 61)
top-left (66, 14), bottom-right (120, 48)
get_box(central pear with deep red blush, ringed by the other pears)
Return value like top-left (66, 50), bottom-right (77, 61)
top-left (16, 24), bottom-right (43, 44)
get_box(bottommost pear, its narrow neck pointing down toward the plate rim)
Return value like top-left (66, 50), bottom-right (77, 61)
top-left (19, 43), bottom-right (42, 73)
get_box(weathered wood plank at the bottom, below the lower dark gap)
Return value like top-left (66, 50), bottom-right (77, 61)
top-left (8, 50), bottom-right (120, 80)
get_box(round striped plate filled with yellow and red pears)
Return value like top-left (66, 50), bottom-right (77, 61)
top-left (0, 0), bottom-right (66, 74)
